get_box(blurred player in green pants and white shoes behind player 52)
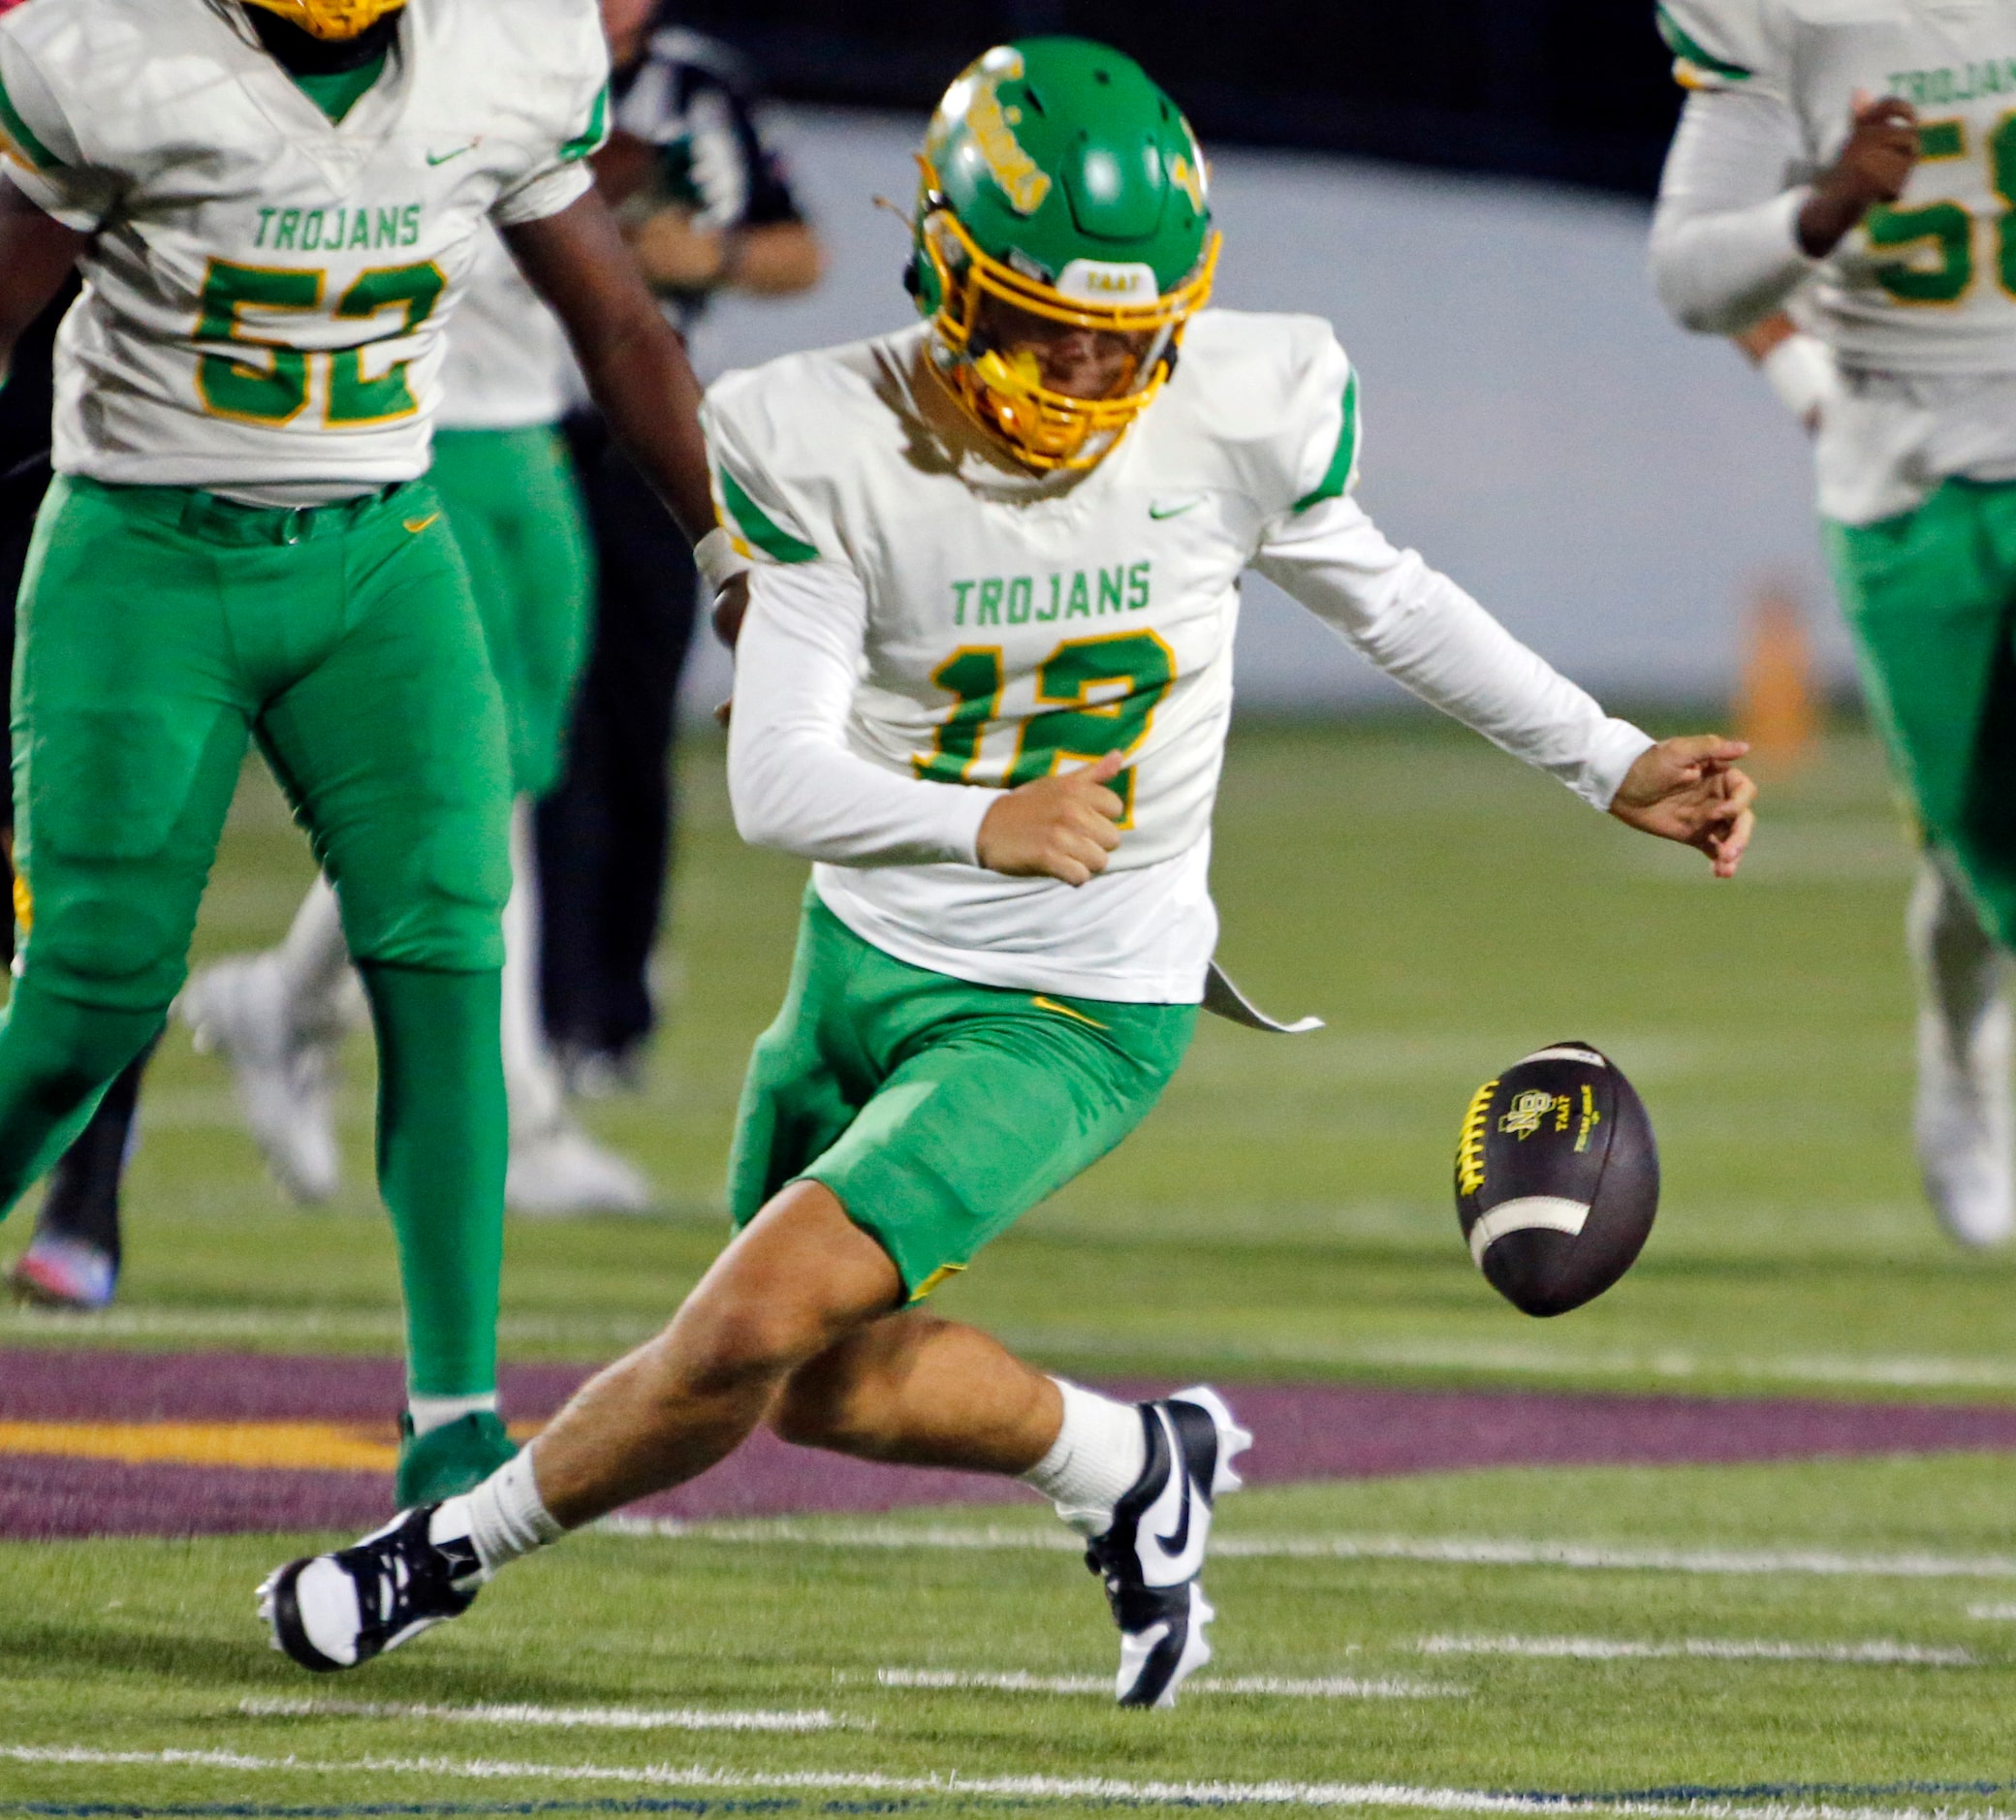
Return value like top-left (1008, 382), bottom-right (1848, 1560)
top-left (177, 232), bottom-right (652, 1215)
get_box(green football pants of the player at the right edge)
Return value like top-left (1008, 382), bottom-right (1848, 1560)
top-left (1826, 480), bottom-right (2016, 950)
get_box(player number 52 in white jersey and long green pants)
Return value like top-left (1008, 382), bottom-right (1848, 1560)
top-left (0, 0), bottom-right (711, 1501)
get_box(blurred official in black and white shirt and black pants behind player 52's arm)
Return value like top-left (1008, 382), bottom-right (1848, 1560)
top-left (538, 0), bottom-right (821, 1092)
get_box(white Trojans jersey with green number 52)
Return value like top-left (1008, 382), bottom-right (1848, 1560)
top-left (0, 0), bottom-right (609, 496)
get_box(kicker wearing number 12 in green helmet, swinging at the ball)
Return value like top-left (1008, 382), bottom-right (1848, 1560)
top-left (262, 39), bottom-right (1754, 1705)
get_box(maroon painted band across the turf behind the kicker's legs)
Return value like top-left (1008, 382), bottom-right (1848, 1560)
top-left (0, 1348), bottom-right (2016, 1540)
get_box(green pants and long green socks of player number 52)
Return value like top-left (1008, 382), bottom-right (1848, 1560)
top-left (0, 478), bottom-right (510, 1395)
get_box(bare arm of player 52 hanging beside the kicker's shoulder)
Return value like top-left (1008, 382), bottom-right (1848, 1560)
top-left (504, 192), bottom-right (713, 545)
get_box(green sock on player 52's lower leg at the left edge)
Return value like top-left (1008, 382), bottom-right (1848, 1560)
top-left (0, 971), bottom-right (168, 1219)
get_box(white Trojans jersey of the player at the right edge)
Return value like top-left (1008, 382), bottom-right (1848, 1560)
top-left (1659, 0), bottom-right (2016, 375)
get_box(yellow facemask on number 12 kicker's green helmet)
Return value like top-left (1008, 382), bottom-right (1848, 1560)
top-left (924, 163), bottom-right (1219, 470)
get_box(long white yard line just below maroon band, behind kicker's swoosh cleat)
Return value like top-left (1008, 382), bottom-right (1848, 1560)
top-left (597, 1518), bottom-right (2016, 1580)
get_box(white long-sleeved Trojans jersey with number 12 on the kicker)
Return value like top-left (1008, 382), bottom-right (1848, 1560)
top-left (704, 310), bottom-right (1649, 1004)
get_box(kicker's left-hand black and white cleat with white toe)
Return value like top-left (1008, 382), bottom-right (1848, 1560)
top-left (258, 1503), bottom-right (489, 1675)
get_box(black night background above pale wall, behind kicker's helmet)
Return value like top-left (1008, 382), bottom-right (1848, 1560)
top-left (676, 0), bottom-right (1680, 196)
